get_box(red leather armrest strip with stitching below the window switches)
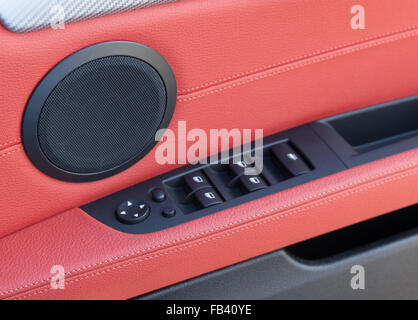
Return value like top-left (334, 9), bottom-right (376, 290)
top-left (0, 150), bottom-right (418, 299)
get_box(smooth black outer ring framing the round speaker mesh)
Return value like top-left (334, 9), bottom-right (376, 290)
top-left (22, 41), bottom-right (177, 182)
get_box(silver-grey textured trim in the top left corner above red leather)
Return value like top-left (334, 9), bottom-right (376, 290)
top-left (0, 0), bottom-right (179, 33)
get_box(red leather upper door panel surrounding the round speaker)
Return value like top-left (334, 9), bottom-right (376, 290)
top-left (0, 0), bottom-right (418, 237)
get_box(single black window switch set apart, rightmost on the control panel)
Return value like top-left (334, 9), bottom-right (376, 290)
top-left (272, 143), bottom-right (311, 176)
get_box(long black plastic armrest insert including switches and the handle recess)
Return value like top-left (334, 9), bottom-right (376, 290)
top-left (82, 96), bottom-right (418, 234)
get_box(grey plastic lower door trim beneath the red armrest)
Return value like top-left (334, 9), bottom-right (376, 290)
top-left (140, 218), bottom-right (418, 300)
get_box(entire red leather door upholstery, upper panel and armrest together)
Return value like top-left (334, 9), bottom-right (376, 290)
top-left (0, 0), bottom-right (418, 299)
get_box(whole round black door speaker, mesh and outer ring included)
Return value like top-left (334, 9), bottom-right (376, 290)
top-left (23, 41), bottom-right (176, 181)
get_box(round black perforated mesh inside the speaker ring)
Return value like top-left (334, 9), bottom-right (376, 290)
top-left (38, 56), bottom-right (167, 173)
